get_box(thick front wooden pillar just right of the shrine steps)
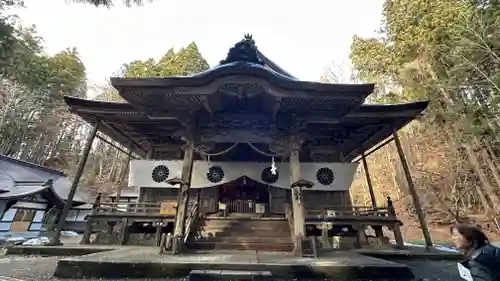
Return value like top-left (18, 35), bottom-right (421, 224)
top-left (290, 138), bottom-right (306, 256)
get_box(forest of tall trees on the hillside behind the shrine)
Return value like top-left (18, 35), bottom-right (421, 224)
top-left (0, 0), bottom-right (500, 241)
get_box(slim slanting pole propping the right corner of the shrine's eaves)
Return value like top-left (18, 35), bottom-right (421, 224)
top-left (392, 129), bottom-right (432, 248)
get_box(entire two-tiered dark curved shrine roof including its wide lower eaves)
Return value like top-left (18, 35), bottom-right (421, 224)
top-left (65, 35), bottom-right (428, 161)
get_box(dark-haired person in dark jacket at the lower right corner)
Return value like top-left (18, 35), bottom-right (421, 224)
top-left (451, 225), bottom-right (500, 281)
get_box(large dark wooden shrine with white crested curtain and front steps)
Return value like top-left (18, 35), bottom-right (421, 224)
top-left (58, 36), bottom-right (431, 255)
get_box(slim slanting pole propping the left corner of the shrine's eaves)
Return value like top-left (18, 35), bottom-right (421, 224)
top-left (50, 122), bottom-right (99, 245)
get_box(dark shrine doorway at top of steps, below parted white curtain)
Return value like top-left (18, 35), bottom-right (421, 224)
top-left (219, 176), bottom-right (270, 215)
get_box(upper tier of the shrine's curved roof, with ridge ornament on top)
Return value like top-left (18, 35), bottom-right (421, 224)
top-left (111, 35), bottom-right (374, 116)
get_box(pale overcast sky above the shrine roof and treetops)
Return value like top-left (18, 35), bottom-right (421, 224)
top-left (9, 0), bottom-right (383, 96)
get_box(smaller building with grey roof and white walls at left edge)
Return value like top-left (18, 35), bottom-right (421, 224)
top-left (0, 155), bottom-right (92, 239)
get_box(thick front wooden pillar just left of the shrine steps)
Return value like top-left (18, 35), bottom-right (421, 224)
top-left (172, 141), bottom-right (194, 254)
